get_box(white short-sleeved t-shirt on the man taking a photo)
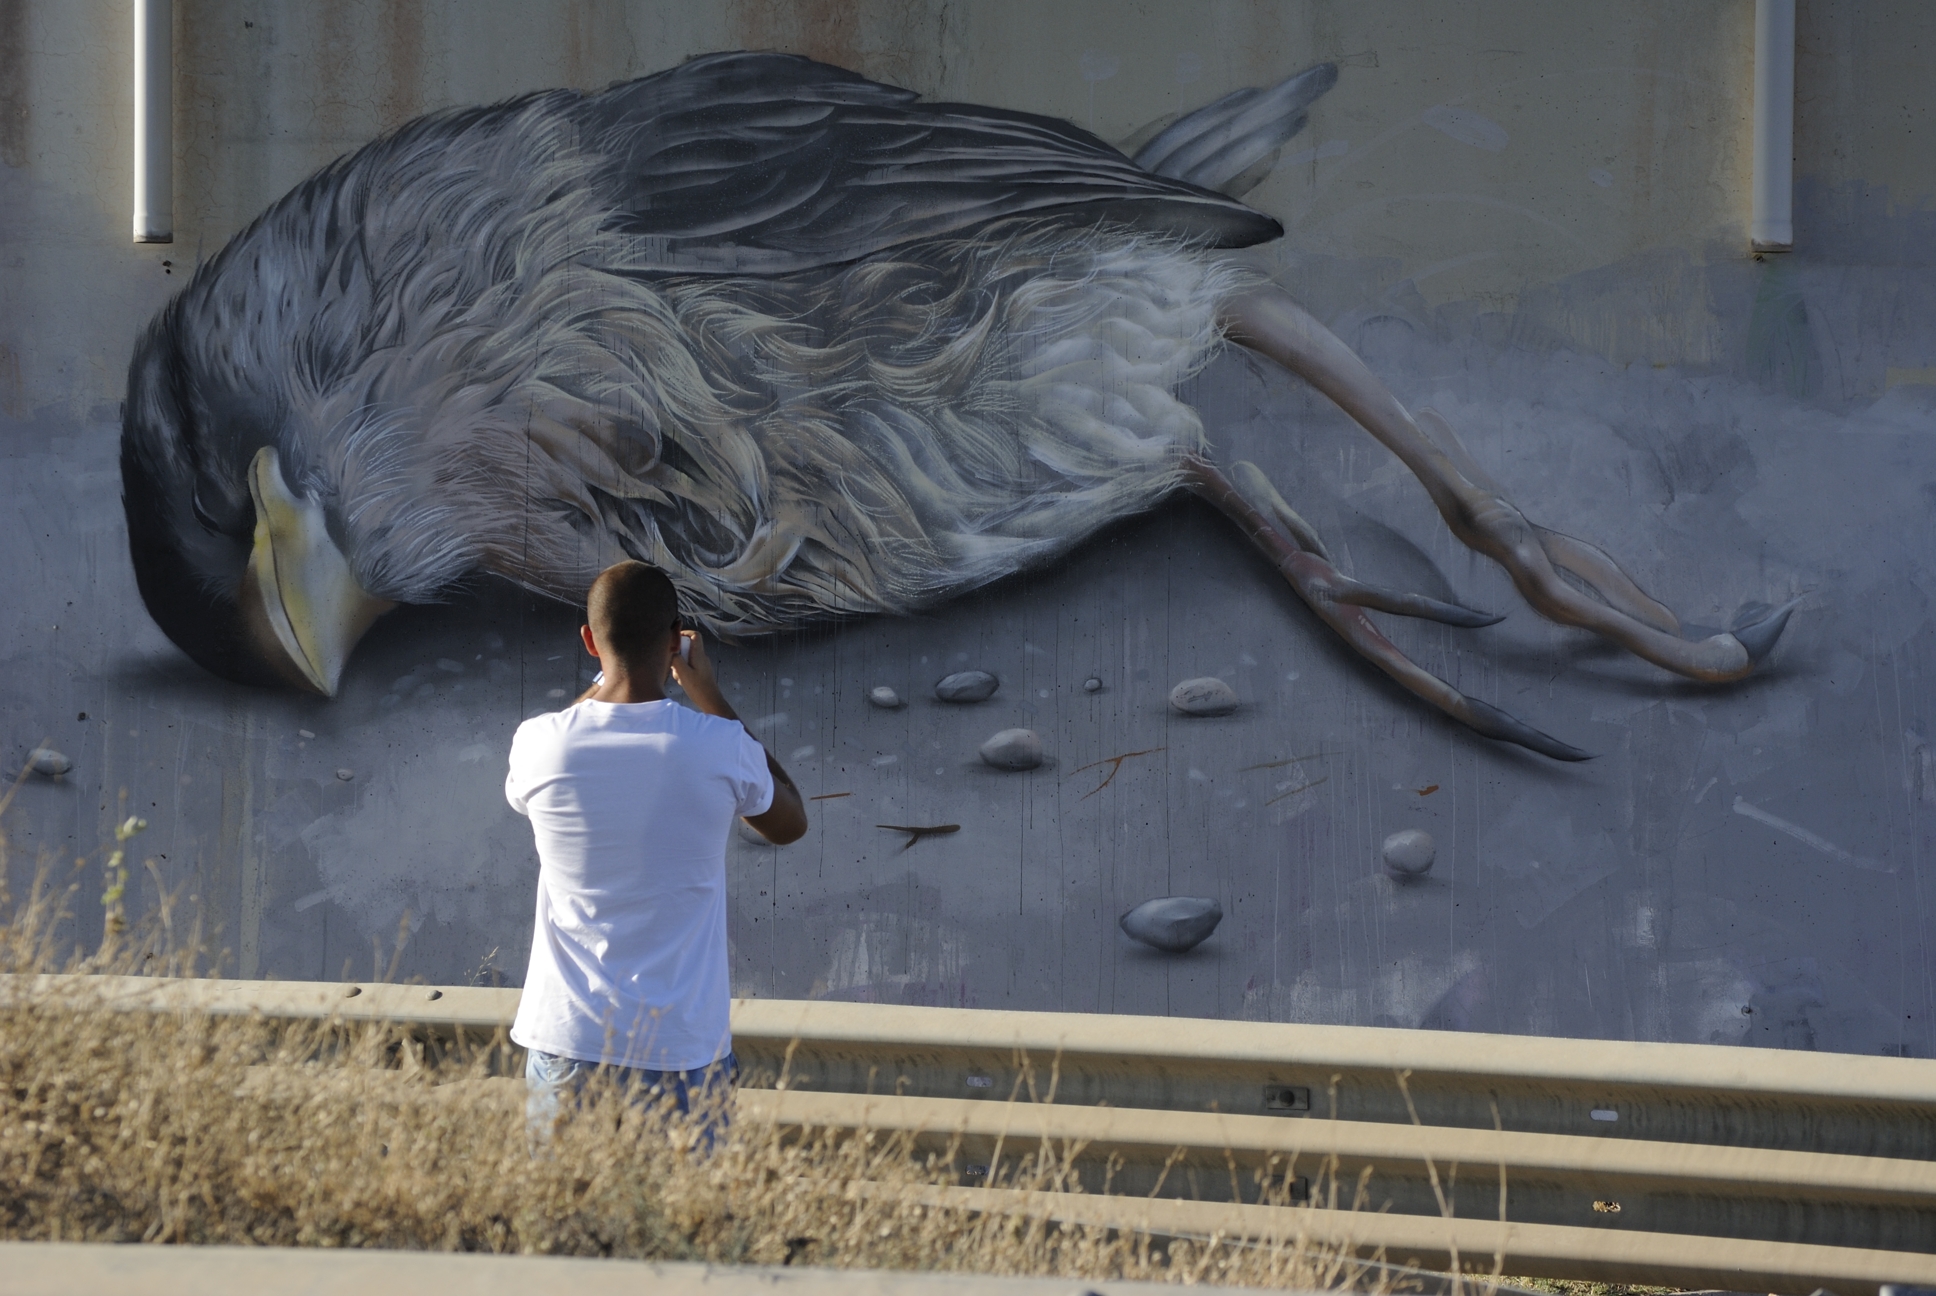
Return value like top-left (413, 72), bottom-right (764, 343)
top-left (503, 699), bottom-right (772, 1071)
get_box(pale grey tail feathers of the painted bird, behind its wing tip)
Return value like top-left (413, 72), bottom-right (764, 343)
top-left (1134, 64), bottom-right (1338, 198)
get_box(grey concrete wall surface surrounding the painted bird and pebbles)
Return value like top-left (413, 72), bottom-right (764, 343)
top-left (0, 0), bottom-right (1936, 1054)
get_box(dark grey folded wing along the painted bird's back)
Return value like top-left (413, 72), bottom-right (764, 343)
top-left (579, 54), bottom-right (1284, 275)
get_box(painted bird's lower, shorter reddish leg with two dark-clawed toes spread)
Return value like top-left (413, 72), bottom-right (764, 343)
top-left (1183, 455), bottom-right (1588, 761)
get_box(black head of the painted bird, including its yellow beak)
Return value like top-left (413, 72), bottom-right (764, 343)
top-left (122, 308), bottom-right (395, 697)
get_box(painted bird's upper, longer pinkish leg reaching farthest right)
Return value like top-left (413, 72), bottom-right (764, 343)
top-left (1220, 287), bottom-right (1795, 682)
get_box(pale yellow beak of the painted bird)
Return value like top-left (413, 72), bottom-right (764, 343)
top-left (242, 446), bottom-right (397, 697)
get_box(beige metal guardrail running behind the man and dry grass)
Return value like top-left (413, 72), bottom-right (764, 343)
top-left (15, 976), bottom-right (1936, 1296)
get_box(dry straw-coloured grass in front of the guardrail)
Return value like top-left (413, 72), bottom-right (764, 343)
top-left (0, 782), bottom-right (1376, 1288)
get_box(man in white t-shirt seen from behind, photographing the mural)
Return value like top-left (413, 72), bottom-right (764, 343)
top-left (503, 562), bottom-right (807, 1129)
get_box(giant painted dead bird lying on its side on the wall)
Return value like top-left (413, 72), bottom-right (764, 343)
top-left (122, 54), bottom-right (1787, 759)
